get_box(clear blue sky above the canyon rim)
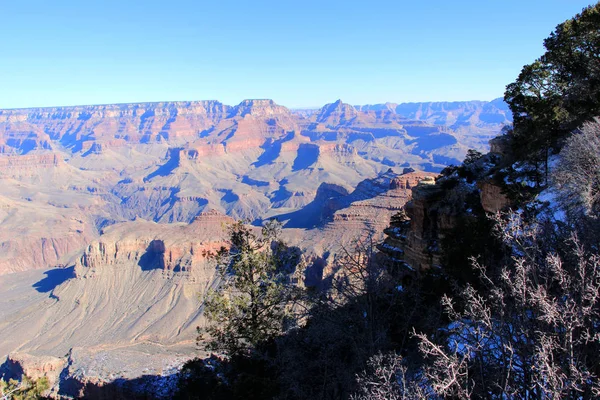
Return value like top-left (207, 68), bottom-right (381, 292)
top-left (0, 0), bottom-right (594, 108)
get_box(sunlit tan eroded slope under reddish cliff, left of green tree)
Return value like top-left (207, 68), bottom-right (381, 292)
top-left (0, 211), bottom-right (239, 380)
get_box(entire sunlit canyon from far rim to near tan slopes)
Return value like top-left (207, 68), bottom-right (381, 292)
top-left (0, 100), bottom-right (511, 396)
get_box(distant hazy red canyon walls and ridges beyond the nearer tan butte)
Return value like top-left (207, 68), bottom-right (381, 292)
top-left (0, 99), bottom-right (506, 274)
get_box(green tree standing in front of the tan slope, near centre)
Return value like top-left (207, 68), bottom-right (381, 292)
top-left (199, 221), bottom-right (299, 356)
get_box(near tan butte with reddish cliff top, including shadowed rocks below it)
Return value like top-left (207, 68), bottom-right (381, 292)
top-left (0, 210), bottom-right (245, 398)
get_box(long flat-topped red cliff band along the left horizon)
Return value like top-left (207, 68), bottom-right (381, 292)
top-left (0, 101), bottom-right (230, 153)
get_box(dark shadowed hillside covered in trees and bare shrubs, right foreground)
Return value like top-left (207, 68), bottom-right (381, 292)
top-left (179, 4), bottom-right (600, 399)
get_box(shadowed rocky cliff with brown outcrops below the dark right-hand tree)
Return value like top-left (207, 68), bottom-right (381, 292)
top-left (379, 153), bottom-right (510, 271)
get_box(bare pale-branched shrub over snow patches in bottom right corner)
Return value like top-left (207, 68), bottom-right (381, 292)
top-left (416, 215), bottom-right (600, 399)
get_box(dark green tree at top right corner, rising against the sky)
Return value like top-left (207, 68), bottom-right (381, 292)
top-left (504, 4), bottom-right (600, 163)
